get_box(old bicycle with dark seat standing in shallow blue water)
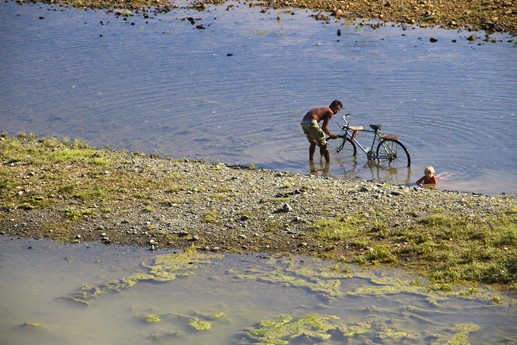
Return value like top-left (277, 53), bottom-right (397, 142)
top-left (330, 114), bottom-right (411, 167)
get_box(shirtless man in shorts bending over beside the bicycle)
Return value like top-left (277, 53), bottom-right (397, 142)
top-left (301, 100), bottom-right (343, 163)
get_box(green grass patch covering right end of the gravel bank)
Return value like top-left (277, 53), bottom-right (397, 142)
top-left (312, 207), bottom-right (517, 286)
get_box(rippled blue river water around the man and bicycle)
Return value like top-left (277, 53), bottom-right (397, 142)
top-left (0, 1), bottom-right (517, 195)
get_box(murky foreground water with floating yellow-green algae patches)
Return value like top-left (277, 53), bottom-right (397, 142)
top-left (0, 237), bottom-right (517, 345)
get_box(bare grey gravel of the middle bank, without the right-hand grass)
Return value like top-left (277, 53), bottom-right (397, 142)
top-left (0, 145), bottom-right (517, 250)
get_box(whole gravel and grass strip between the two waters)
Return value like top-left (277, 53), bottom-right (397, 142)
top-left (0, 137), bottom-right (517, 286)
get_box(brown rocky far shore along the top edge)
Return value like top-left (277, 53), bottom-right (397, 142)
top-left (25, 0), bottom-right (517, 36)
